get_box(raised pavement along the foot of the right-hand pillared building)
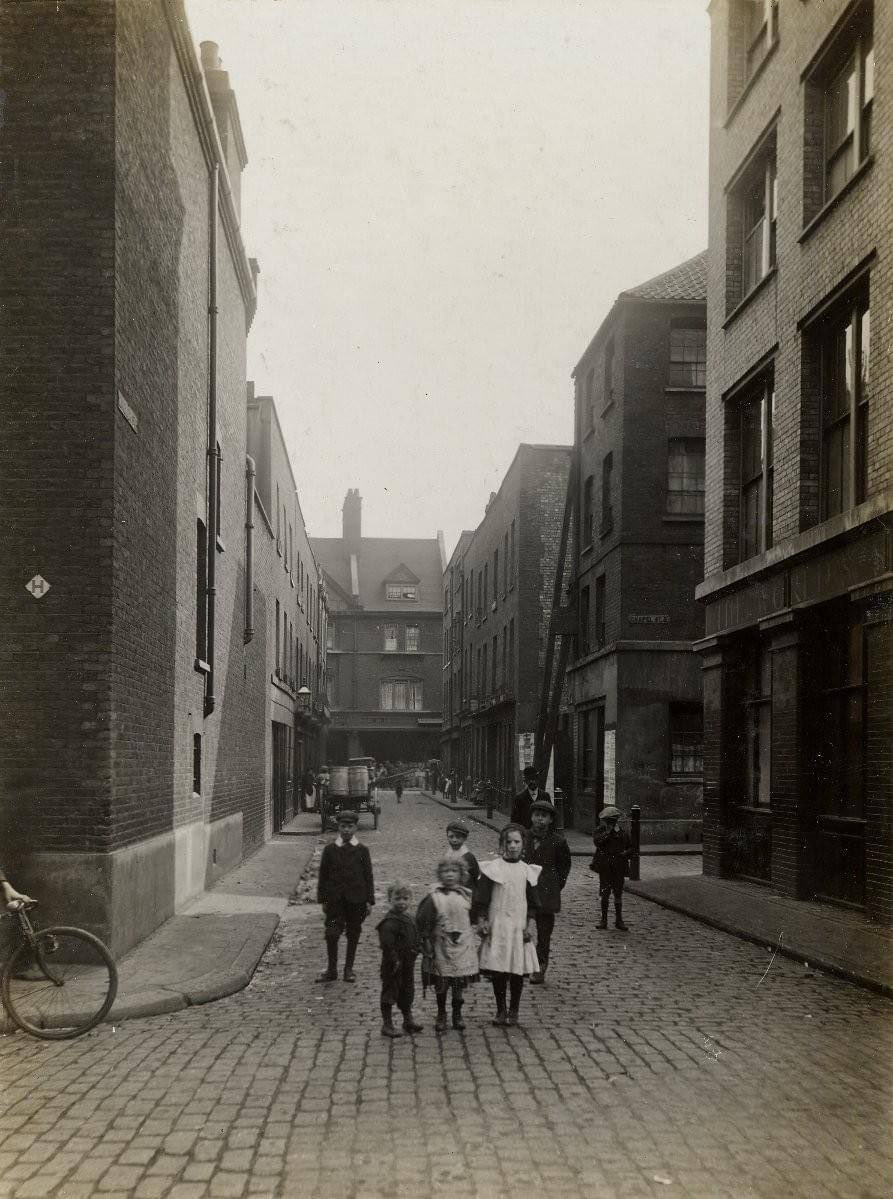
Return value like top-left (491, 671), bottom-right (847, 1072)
top-left (627, 874), bottom-right (893, 996)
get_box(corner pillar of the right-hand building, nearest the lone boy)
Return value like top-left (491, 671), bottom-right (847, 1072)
top-left (695, 637), bottom-right (743, 876)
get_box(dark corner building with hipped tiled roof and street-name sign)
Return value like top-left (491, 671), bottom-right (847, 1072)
top-left (568, 254), bottom-right (706, 842)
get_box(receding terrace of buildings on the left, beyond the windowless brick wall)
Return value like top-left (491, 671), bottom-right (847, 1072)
top-left (246, 384), bottom-right (330, 833)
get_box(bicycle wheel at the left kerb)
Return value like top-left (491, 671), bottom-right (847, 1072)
top-left (0, 927), bottom-right (117, 1041)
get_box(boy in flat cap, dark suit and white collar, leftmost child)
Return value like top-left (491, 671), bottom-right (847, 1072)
top-left (316, 808), bottom-right (375, 982)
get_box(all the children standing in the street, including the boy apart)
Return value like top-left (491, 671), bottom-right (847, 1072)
top-left (316, 800), bottom-right (628, 1037)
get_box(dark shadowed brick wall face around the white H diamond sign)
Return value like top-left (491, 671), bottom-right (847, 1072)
top-left (0, 0), bottom-right (116, 861)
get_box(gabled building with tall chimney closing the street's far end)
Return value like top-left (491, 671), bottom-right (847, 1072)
top-left (310, 489), bottom-right (444, 765)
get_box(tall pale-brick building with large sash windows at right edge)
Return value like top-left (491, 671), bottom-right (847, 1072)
top-left (698, 0), bottom-right (893, 921)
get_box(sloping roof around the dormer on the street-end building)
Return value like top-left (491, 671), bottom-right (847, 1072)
top-left (310, 537), bottom-right (444, 611)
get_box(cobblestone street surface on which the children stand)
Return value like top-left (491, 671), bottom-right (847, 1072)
top-left (0, 793), bottom-right (893, 1199)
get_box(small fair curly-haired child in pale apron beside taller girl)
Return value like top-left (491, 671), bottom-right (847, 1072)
top-left (416, 857), bottom-right (479, 1032)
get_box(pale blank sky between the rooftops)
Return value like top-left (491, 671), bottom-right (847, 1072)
top-left (186, 0), bottom-right (708, 554)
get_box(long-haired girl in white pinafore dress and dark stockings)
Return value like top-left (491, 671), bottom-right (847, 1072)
top-left (471, 824), bottom-right (541, 1028)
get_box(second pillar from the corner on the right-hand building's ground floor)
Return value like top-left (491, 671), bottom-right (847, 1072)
top-left (761, 613), bottom-right (810, 899)
